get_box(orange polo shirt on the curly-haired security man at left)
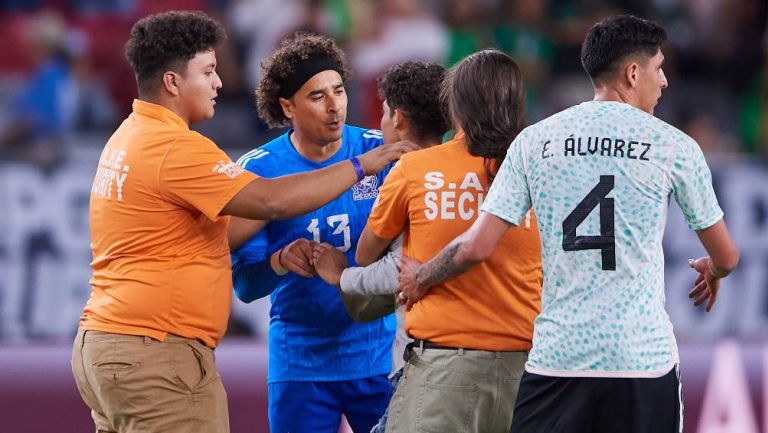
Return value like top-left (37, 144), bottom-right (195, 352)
top-left (80, 100), bottom-right (255, 347)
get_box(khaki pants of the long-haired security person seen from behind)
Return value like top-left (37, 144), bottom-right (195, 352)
top-left (386, 347), bottom-right (528, 433)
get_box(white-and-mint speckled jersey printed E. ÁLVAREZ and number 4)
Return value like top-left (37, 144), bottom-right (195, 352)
top-left (482, 101), bottom-right (723, 377)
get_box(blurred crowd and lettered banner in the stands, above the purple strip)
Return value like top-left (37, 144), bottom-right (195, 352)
top-left (0, 0), bottom-right (768, 341)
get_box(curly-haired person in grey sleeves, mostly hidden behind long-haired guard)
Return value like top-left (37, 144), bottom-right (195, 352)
top-left (313, 62), bottom-right (448, 433)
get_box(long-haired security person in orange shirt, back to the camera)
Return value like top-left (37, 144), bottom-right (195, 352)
top-left (356, 50), bottom-right (542, 433)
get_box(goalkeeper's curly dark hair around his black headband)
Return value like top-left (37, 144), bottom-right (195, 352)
top-left (256, 32), bottom-right (349, 128)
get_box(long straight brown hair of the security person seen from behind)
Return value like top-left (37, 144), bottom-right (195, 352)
top-left (441, 49), bottom-right (526, 180)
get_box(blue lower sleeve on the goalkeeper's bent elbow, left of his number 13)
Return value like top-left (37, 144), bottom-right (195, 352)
top-left (232, 228), bottom-right (282, 302)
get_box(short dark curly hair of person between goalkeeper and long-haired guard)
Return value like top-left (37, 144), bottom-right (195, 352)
top-left (377, 62), bottom-right (448, 140)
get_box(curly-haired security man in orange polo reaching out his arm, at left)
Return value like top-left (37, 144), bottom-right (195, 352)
top-left (72, 12), bottom-right (409, 432)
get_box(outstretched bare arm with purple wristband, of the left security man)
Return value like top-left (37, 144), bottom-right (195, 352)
top-left (221, 141), bottom-right (416, 220)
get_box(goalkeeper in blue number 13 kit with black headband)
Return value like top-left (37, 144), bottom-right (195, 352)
top-left (230, 34), bottom-right (396, 433)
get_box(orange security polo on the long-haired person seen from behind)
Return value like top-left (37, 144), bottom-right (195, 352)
top-left (368, 137), bottom-right (542, 351)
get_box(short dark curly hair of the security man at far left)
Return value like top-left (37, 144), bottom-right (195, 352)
top-left (125, 11), bottom-right (227, 95)
